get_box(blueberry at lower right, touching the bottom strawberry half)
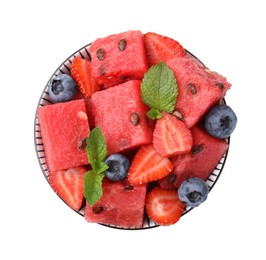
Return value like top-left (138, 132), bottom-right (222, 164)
top-left (178, 177), bottom-right (209, 207)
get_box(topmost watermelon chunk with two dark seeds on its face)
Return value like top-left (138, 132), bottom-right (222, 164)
top-left (90, 31), bottom-right (148, 88)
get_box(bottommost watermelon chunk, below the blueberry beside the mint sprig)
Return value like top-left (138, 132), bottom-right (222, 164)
top-left (84, 178), bottom-right (147, 228)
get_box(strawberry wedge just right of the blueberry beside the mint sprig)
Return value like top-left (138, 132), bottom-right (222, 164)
top-left (128, 144), bottom-right (173, 185)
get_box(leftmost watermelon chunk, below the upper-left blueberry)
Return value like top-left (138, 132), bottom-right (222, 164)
top-left (37, 99), bottom-right (90, 172)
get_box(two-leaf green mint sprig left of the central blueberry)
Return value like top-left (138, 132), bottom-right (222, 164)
top-left (84, 127), bottom-right (109, 206)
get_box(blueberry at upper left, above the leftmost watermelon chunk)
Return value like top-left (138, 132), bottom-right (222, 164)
top-left (48, 74), bottom-right (77, 103)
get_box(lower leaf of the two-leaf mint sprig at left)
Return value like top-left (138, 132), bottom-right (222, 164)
top-left (84, 170), bottom-right (104, 206)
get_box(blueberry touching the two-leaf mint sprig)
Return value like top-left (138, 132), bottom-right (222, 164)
top-left (105, 154), bottom-right (130, 181)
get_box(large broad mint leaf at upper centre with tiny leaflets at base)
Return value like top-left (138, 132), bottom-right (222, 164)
top-left (140, 62), bottom-right (178, 119)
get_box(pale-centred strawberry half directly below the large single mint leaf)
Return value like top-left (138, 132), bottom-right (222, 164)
top-left (153, 112), bottom-right (193, 157)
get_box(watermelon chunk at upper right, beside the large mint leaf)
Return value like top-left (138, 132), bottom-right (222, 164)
top-left (166, 54), bottom-right (231, 128)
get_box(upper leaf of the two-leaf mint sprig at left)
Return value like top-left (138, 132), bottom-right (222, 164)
top-left (86, 127), bottom-right (107, 172)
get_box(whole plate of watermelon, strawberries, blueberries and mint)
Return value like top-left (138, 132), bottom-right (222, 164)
top-left (35, 31), bottom-right (237, 229)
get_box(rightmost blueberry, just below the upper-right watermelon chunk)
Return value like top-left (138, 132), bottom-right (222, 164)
top-left (205, 105), bottom-right (237, 139)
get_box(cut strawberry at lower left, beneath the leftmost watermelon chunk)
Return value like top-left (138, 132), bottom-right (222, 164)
top-left (49, 167), bottom-right (86, 210)
